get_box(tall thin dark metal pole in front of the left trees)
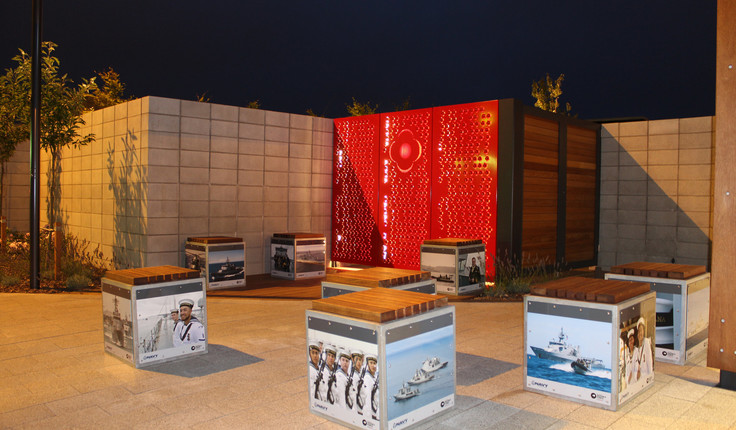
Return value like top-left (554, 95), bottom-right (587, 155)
top-left (30, 0), bottom-right (43, 290)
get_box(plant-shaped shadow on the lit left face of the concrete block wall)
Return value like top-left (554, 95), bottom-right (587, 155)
top-left (107, 130), bottom-right (147, 268)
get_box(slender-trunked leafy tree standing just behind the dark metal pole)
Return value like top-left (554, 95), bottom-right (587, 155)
top-left (13, 42), bottom-right (97, 223)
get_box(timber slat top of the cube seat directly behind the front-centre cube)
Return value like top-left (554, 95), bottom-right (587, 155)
top-left (325, 267), bottom-right (432, 288)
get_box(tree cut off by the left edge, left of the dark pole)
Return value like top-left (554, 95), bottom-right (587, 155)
top-left (0, 69), bottom-right (29, 220)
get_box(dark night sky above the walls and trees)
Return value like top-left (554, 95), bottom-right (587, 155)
top-left (0, 0), bottom-right (716, 119)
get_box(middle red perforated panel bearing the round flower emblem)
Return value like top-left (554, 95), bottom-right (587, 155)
top-left (378, 109), bottom-right (432, 269)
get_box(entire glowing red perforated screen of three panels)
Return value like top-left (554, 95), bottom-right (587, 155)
top-left (332, 101), bottom-right (498, 277)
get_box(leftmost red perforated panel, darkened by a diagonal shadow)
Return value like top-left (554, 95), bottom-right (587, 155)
top-left (332, 115), bottom-right (382, 266)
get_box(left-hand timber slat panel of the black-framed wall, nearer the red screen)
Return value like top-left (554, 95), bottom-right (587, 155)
top-left (521, 115), bottom-right (559, 264)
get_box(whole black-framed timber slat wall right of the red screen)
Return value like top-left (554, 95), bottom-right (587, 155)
top-left (496, 99), bottom-right (600, 267)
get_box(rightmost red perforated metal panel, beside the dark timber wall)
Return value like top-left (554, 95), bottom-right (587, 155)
top-left (431, 101), bottom-right (498, 279)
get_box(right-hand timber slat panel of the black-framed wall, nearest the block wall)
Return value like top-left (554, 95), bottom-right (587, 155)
top-left (565, 126), bottom-right (598, 261)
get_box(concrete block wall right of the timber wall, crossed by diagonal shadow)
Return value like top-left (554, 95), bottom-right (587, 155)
top-left (598, 117), bottom-right (714, 269)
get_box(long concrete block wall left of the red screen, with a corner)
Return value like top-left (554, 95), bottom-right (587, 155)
top-left (26, 97), bottom-right (332, 274)
